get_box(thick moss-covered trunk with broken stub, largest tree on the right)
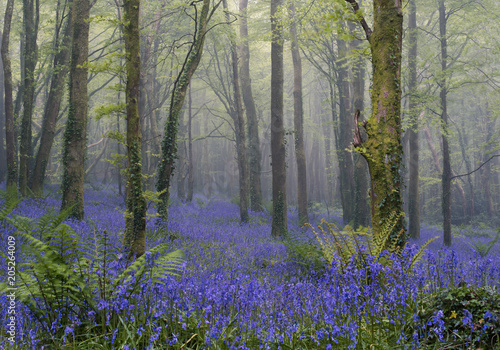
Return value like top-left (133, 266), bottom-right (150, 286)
top-left (346, 0), bottom-right (406, 245)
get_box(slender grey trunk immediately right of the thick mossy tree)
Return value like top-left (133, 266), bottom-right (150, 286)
top-left (408, 0), bottom-right (420, 239)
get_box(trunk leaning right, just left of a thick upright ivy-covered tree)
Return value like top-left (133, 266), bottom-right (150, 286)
top-left (31, 9), bottom-right (72, 196)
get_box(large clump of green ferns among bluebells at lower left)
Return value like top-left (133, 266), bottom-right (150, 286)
top-left (0, 193), bottom-right (184, 349)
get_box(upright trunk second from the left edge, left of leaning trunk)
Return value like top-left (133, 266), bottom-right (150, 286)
top-left (19, 0), bottom-right (40, 196)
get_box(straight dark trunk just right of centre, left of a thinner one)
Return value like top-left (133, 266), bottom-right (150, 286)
top-left (271, 0), bottom-right (287, 238)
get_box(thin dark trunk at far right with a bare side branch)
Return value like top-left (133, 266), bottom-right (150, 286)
top-left (439, 0), bottom-right (451, 246)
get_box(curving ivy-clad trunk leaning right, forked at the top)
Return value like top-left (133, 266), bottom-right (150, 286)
top-left (156, 0), bottom-right (220, 221)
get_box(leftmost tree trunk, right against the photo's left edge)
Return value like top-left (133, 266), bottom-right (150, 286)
top-left (0, 0), bottom-right (17, 189)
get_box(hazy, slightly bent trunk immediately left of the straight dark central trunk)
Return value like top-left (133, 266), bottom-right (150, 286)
top-left (239, 0), bottom-right (263, 211)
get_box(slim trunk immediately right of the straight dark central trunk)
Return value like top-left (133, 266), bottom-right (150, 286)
top-left (288, 0), bottom-right (309, 226)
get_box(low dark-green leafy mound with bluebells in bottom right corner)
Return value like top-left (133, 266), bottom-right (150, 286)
top-left (412, 284), bottom-right (500, 349)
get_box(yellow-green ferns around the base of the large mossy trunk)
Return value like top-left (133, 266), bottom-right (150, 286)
top-left (306, 213), bottom-right (437, 272)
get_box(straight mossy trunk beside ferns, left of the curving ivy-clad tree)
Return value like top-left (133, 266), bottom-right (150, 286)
top-left (123, 0), bottom-right (146, 260)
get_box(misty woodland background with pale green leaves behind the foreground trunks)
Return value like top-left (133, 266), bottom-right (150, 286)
top-left (0, 0), bottom-right (500, 238)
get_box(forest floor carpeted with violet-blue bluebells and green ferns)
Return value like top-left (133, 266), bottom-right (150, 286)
top-left (0, 189), bottom-right (500, 349)
